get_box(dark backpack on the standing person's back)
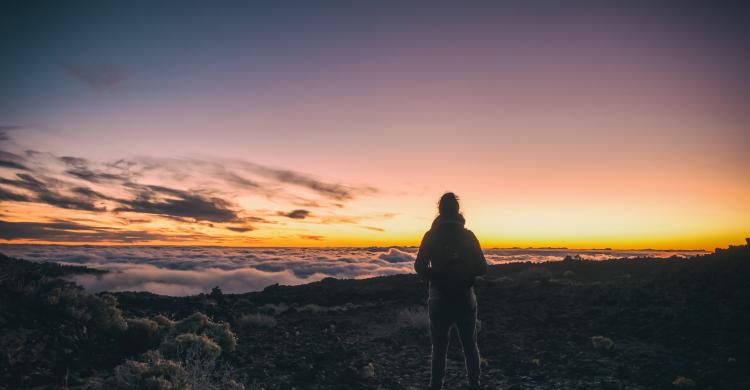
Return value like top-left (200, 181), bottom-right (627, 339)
top-left (430, 227), bottom-right (475, 296)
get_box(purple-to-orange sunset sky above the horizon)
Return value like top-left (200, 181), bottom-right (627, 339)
top-left (0, 1), bottom-right (750, 249)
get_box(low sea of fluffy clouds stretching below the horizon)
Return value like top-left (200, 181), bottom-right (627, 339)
top-left (0, 245), bottom-right (703, 296)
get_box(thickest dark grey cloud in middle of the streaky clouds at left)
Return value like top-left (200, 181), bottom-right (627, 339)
top-left (115, 185), bottom-right (239, 222)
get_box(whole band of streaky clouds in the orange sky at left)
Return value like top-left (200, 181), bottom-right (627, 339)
top-left (0, 134), bottom-right (384, 244)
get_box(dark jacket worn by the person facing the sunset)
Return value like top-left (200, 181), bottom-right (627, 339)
top-left (414, 214), bottom-right (487, 290)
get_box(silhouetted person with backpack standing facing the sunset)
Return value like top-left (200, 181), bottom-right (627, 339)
top-left (414, 192), bottom-right (487, 389)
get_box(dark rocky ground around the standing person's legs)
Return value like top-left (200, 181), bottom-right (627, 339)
top-left (0, 241), bottom-right (750, 389)
